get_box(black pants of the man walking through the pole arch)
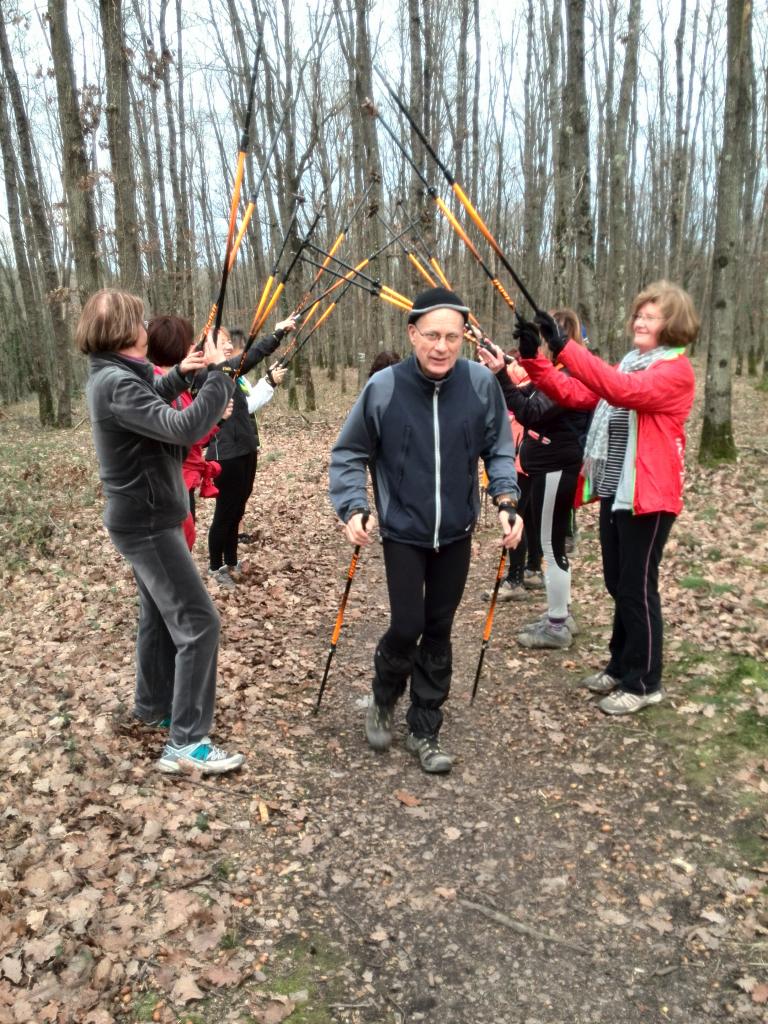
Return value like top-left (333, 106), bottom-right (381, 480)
top-left (374, 537), bottom-right (471, 736)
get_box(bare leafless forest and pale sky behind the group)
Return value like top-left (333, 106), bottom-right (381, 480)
top-left (0, 0), bottom-right (768, 460)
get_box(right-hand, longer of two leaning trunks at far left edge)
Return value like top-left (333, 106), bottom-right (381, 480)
top-left (0, 12), bottom-right (75, 419)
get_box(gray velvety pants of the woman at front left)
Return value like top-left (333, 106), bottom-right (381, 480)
top-left (110, 526), bottom-right (219, 746)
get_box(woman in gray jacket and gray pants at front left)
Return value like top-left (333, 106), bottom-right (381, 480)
top-left (76, 289), bottom-right (245, 773)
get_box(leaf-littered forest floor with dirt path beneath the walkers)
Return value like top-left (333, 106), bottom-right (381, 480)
top-left (0, 370), bottom-right (768, 1024)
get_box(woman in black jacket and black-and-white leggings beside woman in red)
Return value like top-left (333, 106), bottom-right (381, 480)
top-left (478, 309), bottom-right (589, 648)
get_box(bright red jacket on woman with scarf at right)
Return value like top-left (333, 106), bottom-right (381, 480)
top-left (521, 341), bottom-right (694, 515)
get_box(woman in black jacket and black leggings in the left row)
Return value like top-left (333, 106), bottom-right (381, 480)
top-left (206, 317), bottom-right (296, 590)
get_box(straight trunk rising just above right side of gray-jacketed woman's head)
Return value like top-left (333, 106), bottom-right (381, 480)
top-left (98, 0), bottom-right (142, 292)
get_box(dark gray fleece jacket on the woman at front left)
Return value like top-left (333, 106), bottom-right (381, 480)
top-left (85, 352), bottom-right (234, 532)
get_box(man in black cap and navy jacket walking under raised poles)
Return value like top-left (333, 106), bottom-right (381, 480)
top-left (330, 288), bottom-right (522, 772)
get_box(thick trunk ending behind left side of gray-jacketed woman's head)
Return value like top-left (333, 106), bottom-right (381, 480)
top-left (48, 0), bottom-right (100, 304)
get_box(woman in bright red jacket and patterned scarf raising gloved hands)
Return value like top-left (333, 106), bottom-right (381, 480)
top-left (515, 281), bottom-right (699, 715)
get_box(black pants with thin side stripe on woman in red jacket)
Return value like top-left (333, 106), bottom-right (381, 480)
top-left (600, 498), bottom-right (675, 693)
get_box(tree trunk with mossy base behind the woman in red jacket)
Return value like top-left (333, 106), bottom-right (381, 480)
top-left (698, 0), bottom-right (752, 463)
